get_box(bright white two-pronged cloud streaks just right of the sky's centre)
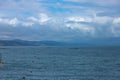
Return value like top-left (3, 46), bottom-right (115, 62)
top-left (65, 16), bottom-right (95, 35)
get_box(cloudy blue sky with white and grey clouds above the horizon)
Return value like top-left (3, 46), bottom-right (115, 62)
top-left (0, 0), bottom-right (120, 41)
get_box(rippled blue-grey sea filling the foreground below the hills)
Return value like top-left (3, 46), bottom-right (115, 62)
top-left (0, 46), bottom-right (120, 80)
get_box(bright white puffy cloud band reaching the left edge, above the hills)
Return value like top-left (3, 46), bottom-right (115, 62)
top-left (0, 13), bottom-right (50, 27)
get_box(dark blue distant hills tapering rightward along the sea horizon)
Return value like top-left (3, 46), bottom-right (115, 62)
top-left (0, 39), bottom-right (64, 46)
